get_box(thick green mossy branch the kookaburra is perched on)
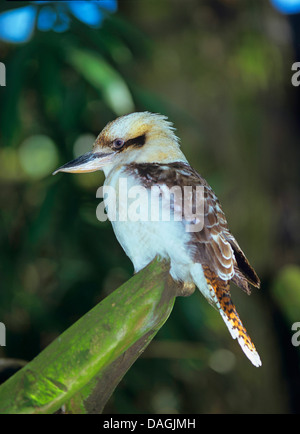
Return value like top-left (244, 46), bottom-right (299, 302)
top-left (0, 259), bottom-right (178, 414)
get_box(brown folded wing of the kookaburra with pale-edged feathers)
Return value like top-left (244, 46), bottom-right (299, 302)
top-left (126, 162), bottom-right (259, 293)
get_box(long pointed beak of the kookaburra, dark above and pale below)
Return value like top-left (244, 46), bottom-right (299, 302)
top-left (52, 152), bottom-right (114, 175)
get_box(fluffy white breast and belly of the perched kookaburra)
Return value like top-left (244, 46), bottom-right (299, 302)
top-left (104, 168), bottom-right (192, 280)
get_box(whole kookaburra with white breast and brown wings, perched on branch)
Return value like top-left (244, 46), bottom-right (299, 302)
top-left (53, 111), bottom-right (261, 367)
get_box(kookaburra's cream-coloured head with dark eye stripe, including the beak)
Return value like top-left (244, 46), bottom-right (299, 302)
top-left (53, 112), bottom-right (186, 175)
